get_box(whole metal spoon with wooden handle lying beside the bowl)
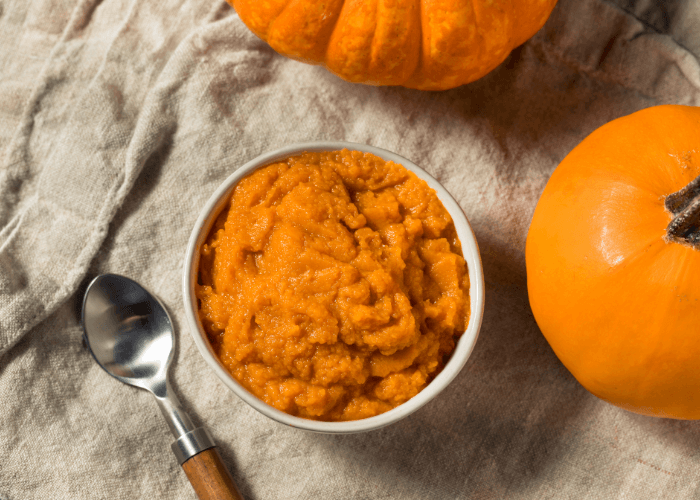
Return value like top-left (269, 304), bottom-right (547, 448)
top-left (82, 274), bottom-right (243, 500)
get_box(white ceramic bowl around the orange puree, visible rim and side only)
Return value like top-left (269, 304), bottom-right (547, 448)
top-left (183, 142), bottom-right (484, 434)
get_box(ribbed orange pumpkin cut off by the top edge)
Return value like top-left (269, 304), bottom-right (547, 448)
top-left (228, 0), bottom-right (556, 90)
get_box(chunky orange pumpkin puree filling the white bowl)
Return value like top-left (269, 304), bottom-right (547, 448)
top-left (196, 150), bottom-right (469, 421)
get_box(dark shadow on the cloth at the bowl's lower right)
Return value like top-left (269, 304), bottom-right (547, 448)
top-left (318, 233), bottom-right (596, 498)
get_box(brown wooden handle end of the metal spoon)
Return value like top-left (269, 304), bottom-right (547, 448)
top-left (182, 448), bottom-right (243, 500)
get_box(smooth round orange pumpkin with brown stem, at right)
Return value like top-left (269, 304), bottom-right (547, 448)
top-left (526, 106), bottom-right (700, 419)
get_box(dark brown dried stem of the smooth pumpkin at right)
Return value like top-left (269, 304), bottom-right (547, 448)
top-left (664, 175), bottom-right (700, 247)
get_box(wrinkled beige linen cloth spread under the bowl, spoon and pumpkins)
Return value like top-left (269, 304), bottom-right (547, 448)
top-left (0, 0), bottom-right (700, 500)
